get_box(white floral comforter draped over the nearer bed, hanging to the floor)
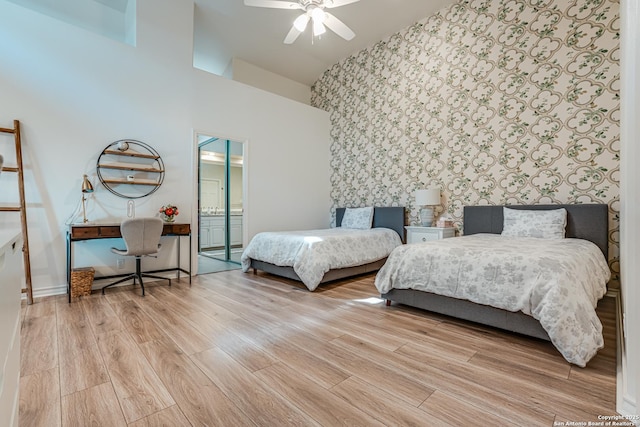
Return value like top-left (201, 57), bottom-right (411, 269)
top-left (375, 234), bottom-right (611, 366)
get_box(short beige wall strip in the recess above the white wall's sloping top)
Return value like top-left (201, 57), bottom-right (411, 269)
top-left (229, 58), bottom-right (311, 105)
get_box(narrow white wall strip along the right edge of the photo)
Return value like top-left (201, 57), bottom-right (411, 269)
top-left (616, 0), bottom-right (640, 425)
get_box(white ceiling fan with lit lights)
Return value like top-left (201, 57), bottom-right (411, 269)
top-left (244, 0), bottom-right (359, 44)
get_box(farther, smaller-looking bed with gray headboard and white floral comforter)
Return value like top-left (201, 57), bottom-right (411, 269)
top-left (241, 206), bottom-right (405, 291)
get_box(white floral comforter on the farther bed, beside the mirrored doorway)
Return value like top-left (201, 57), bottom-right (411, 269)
top-left (240, 227), bottom-right (402, 291)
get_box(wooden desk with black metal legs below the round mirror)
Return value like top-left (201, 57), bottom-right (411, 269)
top-left (67, 222), bottom-right (191, 302)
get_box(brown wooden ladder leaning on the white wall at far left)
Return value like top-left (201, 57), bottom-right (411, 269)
top-left (0, 120), bottom-right (33, 304)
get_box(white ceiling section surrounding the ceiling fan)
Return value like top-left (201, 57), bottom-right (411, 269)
top-left (194, 0), bottom-right (455, 86)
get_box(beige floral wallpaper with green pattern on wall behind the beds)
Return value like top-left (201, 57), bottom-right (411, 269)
top-left (312, 0), bottom-right (620, 288)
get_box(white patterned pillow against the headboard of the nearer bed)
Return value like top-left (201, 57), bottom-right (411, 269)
top-left (502, 208), bottom-right (567, 239)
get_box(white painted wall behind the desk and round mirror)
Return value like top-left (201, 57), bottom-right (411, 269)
top-left (0, 0), bottom-right (330, 296)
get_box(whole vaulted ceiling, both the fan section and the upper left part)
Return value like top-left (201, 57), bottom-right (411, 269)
top-left (6, 0), bottom-right (456, 85)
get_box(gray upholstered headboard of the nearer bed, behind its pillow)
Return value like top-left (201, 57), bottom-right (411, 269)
top-left (463, 204), bottom-right (609, 259)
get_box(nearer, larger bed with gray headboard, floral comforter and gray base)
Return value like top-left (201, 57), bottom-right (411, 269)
top-left (376, 204), bottom-right (610, 366)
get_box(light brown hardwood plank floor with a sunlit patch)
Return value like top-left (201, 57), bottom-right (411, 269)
top-left (20, 270), bottom-right (616, 427)
